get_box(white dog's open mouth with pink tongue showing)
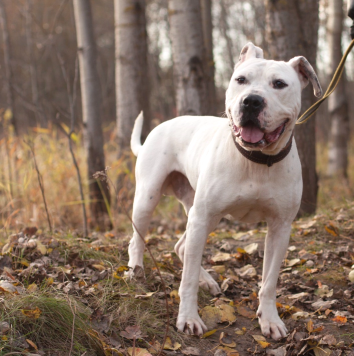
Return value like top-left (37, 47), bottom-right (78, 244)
top-left (232, 119), bottom-right (289, 146)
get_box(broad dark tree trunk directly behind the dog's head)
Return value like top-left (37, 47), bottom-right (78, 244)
top-left (265, 0), bottom-right (319, 214)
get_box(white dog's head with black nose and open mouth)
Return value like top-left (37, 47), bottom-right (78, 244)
top-left (226, 43), bottom-right (322, 155)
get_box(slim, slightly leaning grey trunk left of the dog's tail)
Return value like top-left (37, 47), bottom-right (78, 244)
top-left (73, 0), bottom-right (110, 229)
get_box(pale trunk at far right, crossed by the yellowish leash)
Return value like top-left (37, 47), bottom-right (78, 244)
top-left (327, 0), bottom-right (349, 177)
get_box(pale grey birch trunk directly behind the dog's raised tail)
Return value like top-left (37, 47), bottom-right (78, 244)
top-left (114, 0), bottom-right (150, 150)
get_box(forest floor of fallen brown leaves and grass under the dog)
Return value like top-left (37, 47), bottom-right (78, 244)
top-left (0, 199), bottom-right (354, 356)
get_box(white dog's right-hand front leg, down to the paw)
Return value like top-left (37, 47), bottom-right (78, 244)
top-left (257, 220), bottom-right (291, 340)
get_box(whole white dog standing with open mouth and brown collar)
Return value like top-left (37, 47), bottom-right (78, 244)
top-left (129, 43), bottom-right (322, 339)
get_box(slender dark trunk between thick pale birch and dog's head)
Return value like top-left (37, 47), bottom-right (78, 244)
top-left (200, 0), bottom-right (216, 115)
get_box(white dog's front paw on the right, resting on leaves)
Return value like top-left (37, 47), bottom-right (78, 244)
top-left (257, 305), bottom-right (288, 340)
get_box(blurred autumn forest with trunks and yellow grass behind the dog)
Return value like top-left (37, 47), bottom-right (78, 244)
top-left (0, 0), bottom-right (354, 234)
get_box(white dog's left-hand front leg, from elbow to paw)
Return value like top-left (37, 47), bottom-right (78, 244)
top-left (177, 207), bottom-right (220, 336)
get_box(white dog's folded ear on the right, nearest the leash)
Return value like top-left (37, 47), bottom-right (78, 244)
top-left (288, 56), bottom-right (322, 98)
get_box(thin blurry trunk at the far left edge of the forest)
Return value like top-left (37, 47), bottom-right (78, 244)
top-left (0, 0), bottom-right (18, 135)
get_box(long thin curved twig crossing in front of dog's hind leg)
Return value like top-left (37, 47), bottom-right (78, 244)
top-left (95, 167), bottom-right (170, 356)
